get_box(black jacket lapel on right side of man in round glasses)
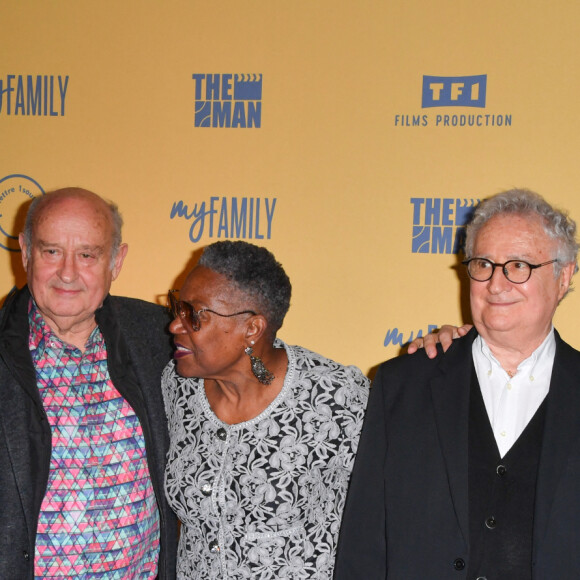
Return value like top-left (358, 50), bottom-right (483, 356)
top-left (533, 332), bottom-right (580, 558)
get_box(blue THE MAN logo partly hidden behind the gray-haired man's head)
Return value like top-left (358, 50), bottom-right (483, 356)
top-left (411, 197), bottom-right (479, 254)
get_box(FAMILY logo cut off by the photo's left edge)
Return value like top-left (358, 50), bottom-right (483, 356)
top-left (0, 75), bottom-right (69, 117)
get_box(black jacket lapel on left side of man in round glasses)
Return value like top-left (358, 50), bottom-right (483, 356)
top-left (431, 330), bottom-right (477, 546)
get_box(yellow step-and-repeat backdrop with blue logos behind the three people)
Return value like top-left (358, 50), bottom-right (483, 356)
top-left (0, 0), bottom-right (580, 374)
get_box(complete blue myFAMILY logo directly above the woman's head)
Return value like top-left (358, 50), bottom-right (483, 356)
top-left (169, 197), bottom-right (277, 243)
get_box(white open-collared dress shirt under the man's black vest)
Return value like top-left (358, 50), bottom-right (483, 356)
top-left (472, 328), bottom-right (556, 457)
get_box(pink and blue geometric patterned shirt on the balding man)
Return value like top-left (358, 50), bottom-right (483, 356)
top-left (29, 300), bottom-right (159, 580)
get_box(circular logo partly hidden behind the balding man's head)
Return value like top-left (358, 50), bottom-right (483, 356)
top-left (0, 174), bottom-right (44, 252)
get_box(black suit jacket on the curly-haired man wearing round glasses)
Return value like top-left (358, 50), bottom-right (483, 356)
top-left (335, 330), bottom-right (580, 580)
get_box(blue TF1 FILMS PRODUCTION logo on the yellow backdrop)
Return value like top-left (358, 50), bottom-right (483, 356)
top-left (395, 75), bottom-right (512, 128)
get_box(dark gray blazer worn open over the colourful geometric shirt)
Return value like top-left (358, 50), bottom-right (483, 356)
top-left (0, 287), bottom-right (177, 580)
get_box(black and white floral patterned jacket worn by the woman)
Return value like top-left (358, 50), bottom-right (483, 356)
top-left (162, 340), bottom-right (369, 580)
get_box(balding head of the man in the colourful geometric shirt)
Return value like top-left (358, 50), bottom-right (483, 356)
top-left (18, 188), bottom-right (127, 350)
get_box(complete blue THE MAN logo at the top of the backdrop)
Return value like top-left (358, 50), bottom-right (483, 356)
top-left (192, 74), bottom-right (262, 129)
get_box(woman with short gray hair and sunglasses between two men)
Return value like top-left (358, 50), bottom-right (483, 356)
top-left (162, 241), bottom-right (368, 580)
